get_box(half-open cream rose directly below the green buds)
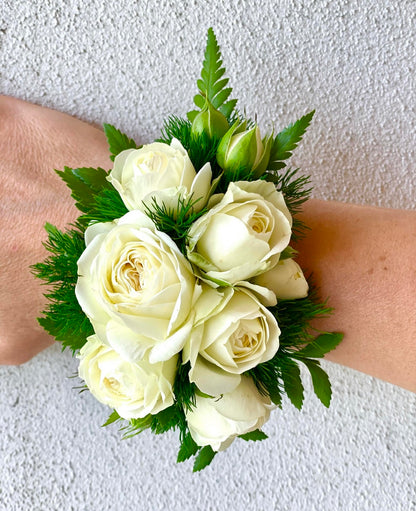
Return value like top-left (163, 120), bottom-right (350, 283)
top-left (188, 180), bottom-right (292, 284)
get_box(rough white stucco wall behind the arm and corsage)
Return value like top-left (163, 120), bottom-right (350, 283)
top-left (0, 0), bottom-right (416, 511)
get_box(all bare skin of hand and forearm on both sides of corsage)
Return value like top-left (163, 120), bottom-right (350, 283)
top-left (0, 96), bottom-right (416, 391)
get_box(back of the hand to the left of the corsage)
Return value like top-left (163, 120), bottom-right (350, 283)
top-left (0, 96), bottom-right (111, 364)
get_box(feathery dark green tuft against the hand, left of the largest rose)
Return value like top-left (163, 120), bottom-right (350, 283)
top-left (32, 224), bottom-right (94, 353)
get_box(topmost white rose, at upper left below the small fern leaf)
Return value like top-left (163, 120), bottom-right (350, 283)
top-left (108, 139), bottom-right (212, 211)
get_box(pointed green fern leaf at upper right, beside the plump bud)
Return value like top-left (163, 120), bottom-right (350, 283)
top-left (267, 110), bottom-right (315, 170)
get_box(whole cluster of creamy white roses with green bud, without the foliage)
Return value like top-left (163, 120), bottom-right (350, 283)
top-left (76, 135), bottom-right (308, 451)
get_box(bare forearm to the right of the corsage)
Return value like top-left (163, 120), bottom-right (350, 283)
top-left (296, 199), bottom-right (416, 392)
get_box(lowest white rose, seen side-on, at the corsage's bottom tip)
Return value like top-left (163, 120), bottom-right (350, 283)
top-left (185, 376), bottom-right (274, 451)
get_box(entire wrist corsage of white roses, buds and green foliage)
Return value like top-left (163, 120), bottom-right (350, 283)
top-left (33, 29), bottom-right (342, 471)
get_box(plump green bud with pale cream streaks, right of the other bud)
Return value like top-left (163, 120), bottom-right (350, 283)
top-left (217, 121), bottom-right (272, 177)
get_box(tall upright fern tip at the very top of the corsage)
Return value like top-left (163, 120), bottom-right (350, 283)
top-left (188, 28), bottom-right (237, 121)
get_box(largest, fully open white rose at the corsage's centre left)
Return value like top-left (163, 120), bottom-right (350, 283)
top-left (75, 211), bottom-right (198, 363)
